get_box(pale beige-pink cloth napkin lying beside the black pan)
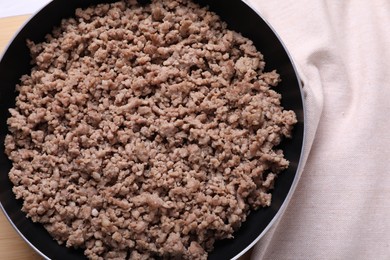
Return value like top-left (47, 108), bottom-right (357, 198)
top-left (248, 0), bottom-right (390, 260)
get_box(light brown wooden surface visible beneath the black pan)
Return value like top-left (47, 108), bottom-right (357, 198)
top-left (0, 15), bottom-right (253, 260)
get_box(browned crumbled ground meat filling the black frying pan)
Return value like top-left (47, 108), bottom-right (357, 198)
top-left (5, 0), bottom-right (296, 259)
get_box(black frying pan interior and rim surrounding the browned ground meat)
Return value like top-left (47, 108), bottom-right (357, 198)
top-left (0, 0), bottom-right (304, 260)
